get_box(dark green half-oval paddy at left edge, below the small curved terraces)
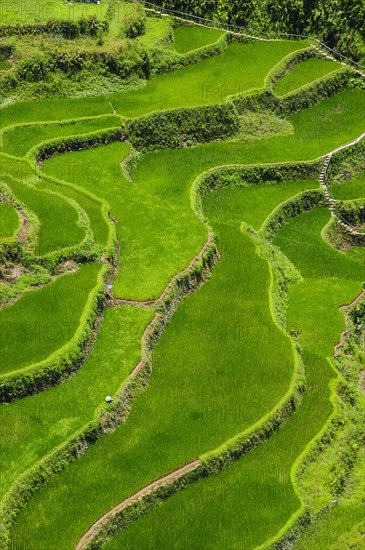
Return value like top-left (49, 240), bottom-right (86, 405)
top-left (0, 264), bottom-right (100, 380)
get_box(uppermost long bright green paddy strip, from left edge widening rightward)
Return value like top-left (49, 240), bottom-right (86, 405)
top-left (0, 41), bottom-right (303, 128)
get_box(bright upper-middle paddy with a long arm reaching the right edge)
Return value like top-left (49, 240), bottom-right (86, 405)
top-left (44, 90), bottom-right (365, 298)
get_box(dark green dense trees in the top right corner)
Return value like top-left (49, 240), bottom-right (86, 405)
top-left (155, 0), bottom-right (365, 61)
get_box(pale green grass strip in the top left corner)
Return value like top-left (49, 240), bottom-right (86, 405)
top-left (0, 0), bottom-right (108, 25)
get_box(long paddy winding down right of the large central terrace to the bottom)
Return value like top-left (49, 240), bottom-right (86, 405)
top-left (101, 208), bottom-right (363, 550)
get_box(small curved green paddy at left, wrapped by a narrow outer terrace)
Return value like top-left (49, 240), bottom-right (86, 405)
top-left (3, 178), bottom-right (85, 256)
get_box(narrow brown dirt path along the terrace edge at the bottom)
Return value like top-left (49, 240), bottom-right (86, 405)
top-left (75, 460), bottom-right (202, 550)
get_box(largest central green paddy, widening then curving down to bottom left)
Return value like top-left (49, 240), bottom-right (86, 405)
top-left (7, 182), bottom-right (316, 548)
